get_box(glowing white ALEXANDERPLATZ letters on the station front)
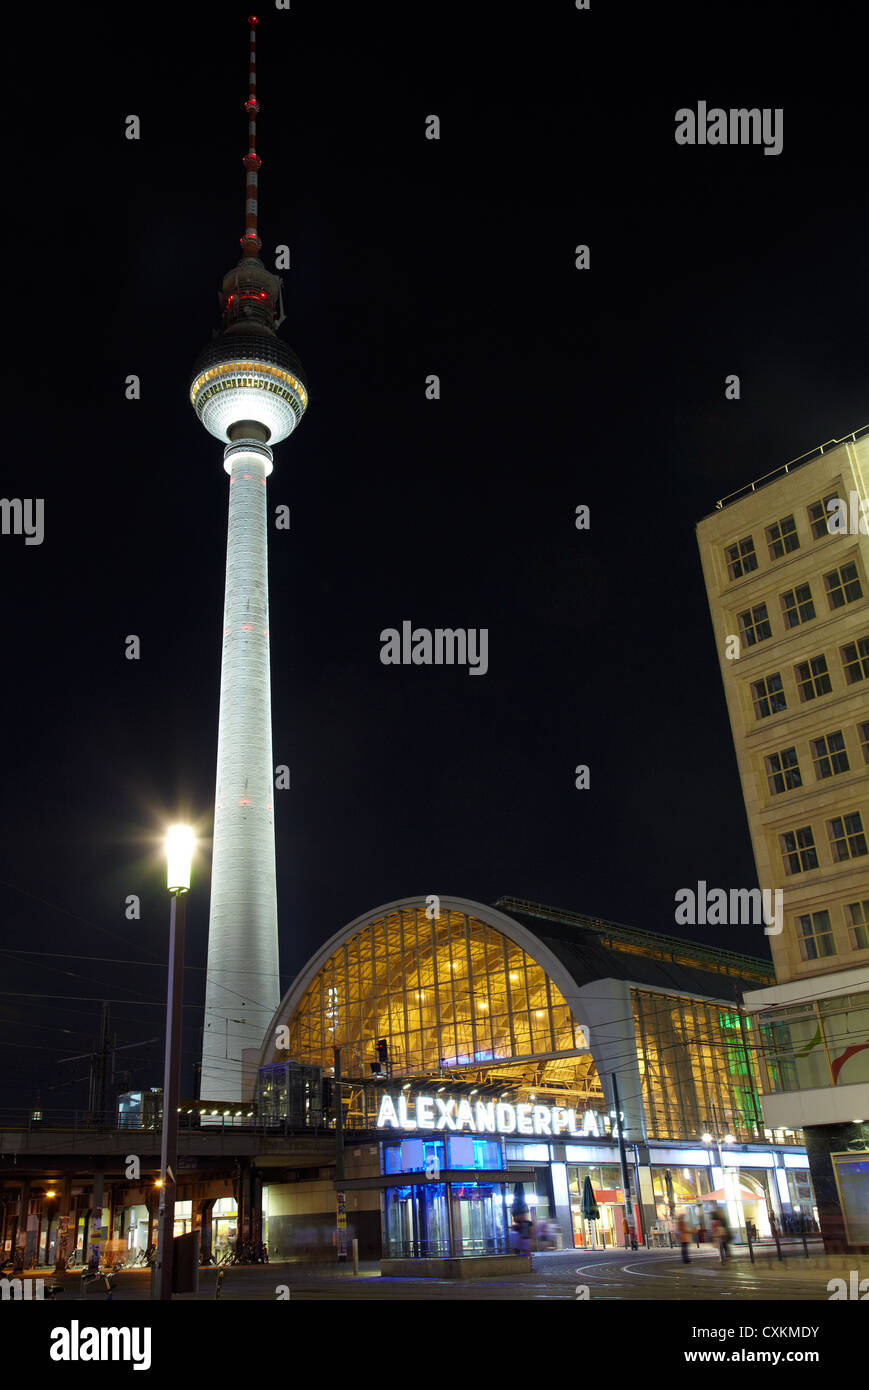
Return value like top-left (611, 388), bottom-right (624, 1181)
top-left (377, 1095), bottom-right (610, 1138)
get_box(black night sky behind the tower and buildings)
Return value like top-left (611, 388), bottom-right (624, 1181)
top-left (0, 0), bottom-right (869, 1119)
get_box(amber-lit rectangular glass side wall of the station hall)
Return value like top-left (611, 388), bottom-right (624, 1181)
top-left (631, 990), bottom-right (763, 1143)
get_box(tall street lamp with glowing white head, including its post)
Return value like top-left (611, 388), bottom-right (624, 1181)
top-left (152, 826), bottom-right (193, 1298)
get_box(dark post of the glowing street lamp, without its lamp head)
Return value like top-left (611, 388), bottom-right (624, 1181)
top-left (152, 891), bottom-right (186, 1300)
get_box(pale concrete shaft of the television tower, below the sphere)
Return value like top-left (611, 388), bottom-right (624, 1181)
top-left (200, 441), bottom-right (281, 1101)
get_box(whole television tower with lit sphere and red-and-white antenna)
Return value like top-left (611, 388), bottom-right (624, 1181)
top-left (190, 15), bottom-right (307, 1101)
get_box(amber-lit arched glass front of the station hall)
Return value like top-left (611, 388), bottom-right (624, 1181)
top-left (269, 908), bottom-right (603, 1129)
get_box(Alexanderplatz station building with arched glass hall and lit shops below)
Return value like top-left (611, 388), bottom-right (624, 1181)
top-left (257, 898), bottom-right (808, 1258)
